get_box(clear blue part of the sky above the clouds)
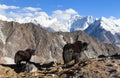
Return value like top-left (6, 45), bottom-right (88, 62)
top-left (0, 0), bottom-right (120, 18)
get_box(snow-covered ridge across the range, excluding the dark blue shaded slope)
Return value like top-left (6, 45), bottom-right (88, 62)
top-left (0, 12), bottom-right (120, 34)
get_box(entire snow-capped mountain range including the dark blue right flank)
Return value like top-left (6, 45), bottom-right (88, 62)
top-left (0, 13), bottom-right (120, 46)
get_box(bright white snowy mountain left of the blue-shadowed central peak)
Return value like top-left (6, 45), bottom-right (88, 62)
top-left (15, 15), bottom-right (69, 32)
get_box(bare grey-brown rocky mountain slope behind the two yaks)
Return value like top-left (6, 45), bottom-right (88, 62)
top-left (0, 21), bottom-right (120, 64)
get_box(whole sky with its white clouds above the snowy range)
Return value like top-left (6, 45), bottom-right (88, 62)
top-left (0, 0), bottom-right (120, 19)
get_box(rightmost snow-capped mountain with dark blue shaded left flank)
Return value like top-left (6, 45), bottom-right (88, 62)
top-left (85, 17), bottom-right (120, 46)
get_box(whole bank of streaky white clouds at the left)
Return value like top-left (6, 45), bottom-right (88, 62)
top-left (0, 4), bottom-right (41, 19)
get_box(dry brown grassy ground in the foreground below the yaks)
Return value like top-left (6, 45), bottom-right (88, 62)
top-left (0, 58), bottom-right (120, 78)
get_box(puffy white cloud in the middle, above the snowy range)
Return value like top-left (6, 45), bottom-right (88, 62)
top-left (52, 8), bottom-right (78, 22)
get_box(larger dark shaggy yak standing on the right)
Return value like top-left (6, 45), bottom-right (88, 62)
top-left (63, 41), bottom-right (88, 64)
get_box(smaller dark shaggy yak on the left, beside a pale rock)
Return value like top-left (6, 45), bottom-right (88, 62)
top-left (14, 49), bottom-right (35, 66)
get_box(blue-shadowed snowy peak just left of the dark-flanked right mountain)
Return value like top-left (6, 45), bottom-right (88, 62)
top-left (69, 16), bottom-right (94, 31)
